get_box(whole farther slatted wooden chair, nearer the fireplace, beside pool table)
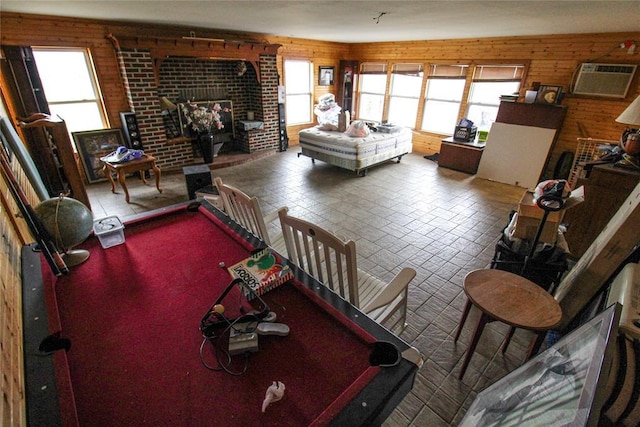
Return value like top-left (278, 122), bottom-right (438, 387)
top-left (214, 177), bottom-right (286, 254)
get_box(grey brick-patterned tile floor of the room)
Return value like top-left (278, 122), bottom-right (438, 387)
top-left (89, 146), bottom-right (531, 427)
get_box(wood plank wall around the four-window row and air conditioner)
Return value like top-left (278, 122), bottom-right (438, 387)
top-left (350, 32), bottom-right (640, 174)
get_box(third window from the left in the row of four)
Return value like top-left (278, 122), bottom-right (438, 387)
top-left (421, 64), bottom-right (469, 135)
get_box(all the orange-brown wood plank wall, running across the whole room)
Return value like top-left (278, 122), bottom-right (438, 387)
top-left (0, 13), bottom-right (640, 164)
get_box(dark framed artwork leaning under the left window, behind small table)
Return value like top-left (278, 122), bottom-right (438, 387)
top-left (72, 128), bottom-right (125, 184)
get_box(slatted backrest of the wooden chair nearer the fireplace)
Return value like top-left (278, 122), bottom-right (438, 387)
top-left (214, 177), bottom-right (271, 245)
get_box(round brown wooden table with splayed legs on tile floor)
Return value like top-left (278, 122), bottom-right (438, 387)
top-left (454, 269), bottom-right (562, 378)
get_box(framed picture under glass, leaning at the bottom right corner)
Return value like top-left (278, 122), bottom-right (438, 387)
top-left (460, 303), bottom-right (622, 427)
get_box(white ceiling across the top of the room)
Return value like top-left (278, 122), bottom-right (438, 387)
top-left (0, 0), bottom-right (640, 43)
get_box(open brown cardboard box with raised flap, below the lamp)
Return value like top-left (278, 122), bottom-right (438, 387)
top-left (512, 187), bottom-right (584, 244)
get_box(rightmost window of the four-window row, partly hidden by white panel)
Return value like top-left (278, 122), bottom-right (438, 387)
top-left (466, 65), bottom-right (524, 129)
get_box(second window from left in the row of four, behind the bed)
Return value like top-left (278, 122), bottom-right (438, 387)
top-left (387, 64), bottom-right (424, 128)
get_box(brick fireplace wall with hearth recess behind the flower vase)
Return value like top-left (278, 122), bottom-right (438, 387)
top-left (117, 42), bottom-right (279, 169)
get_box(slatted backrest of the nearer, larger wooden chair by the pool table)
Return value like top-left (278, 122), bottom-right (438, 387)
top-left (278, 208), bottom-right (360, 307)
